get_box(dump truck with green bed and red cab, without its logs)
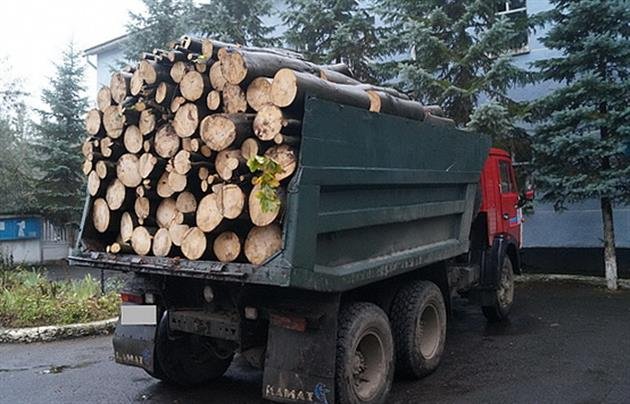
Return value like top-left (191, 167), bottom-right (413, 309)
top-left (70, 98), bottom-right (531, 403)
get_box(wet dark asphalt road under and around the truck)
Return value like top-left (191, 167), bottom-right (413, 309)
top-left (0, 283), bottom-right (630, 404)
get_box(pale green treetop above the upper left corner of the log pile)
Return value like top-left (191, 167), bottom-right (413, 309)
top-left (125, 0), bottom-right (194, 60)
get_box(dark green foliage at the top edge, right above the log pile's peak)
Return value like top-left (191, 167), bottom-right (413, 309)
top-left (193, 0), bottom-right (275, 46)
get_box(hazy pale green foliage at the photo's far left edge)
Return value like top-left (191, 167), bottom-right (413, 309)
top-left (0, 61), bottom-right (33, 214)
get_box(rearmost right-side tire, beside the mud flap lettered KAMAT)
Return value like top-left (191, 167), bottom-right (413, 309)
top-left (335, 303), bottom-right (394, 404)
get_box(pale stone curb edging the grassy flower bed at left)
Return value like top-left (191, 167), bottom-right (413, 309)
top-left (0, 317), bottom-right (118, 343)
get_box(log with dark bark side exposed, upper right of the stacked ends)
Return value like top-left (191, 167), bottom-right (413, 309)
top-left (199, 114), bottom-right (255, 151)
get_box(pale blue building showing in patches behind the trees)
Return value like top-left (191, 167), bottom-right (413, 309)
top-left (85, 0), bottom-right (630, 278)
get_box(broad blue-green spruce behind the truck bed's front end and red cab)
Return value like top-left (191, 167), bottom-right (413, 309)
top-left (378, 0), bottom-right (528, 126)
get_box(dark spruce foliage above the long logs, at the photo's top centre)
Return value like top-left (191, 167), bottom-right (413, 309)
top-left (282, 0), bottom-right (380, 82)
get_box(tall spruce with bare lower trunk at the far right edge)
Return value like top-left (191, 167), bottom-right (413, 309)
top-left (533, 0), bottom-right (630, 289)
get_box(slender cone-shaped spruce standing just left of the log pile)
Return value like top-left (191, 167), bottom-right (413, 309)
top-left (34, 43), bottom-right (88, 224)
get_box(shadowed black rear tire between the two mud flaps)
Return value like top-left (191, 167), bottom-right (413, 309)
top-left (156, 314), bottom-right (234, 386)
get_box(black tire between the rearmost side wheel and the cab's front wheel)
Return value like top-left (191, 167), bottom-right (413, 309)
top-left (390, 281), bottom-right (446, 379)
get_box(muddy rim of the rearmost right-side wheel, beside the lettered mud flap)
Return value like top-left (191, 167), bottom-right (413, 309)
top-left (351, 331), bottom-right (387, 401)
